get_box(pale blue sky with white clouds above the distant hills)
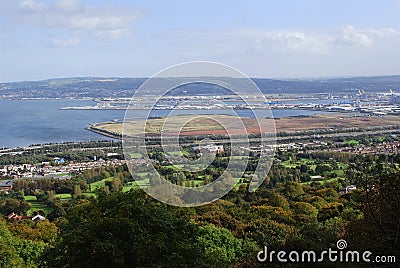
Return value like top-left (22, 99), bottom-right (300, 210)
top-left (0, 0), bottom-right (400, 82)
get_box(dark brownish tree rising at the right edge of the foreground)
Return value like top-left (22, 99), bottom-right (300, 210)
top-left (347, 158), bottom-right (400, 256)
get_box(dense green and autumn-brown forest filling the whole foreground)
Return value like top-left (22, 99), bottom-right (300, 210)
top-left (0, 148), bottom-right (400, 267)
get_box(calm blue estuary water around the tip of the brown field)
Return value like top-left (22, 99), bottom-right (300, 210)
top-left (0, 100), bottom-right (321, 148)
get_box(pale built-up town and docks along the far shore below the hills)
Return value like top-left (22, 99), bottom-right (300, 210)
top-left (60, 89), bottom-right (400, 116)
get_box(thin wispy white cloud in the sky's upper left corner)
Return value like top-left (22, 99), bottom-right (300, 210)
top-left (9, 0), bottom-right (139, 44)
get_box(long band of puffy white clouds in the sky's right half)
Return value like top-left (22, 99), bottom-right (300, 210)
top-left (168, 25), bottom-right (400, 56)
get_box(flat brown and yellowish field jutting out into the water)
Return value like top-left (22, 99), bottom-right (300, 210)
top-left (89, 114), bottom-right (400, 136)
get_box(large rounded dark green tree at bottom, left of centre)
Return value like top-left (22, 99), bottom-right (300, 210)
top-left (43, 190), bottom-right (202, 267)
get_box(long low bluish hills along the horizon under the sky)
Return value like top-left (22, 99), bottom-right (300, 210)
top-left (0, 75), bottom-right (400, 99)
